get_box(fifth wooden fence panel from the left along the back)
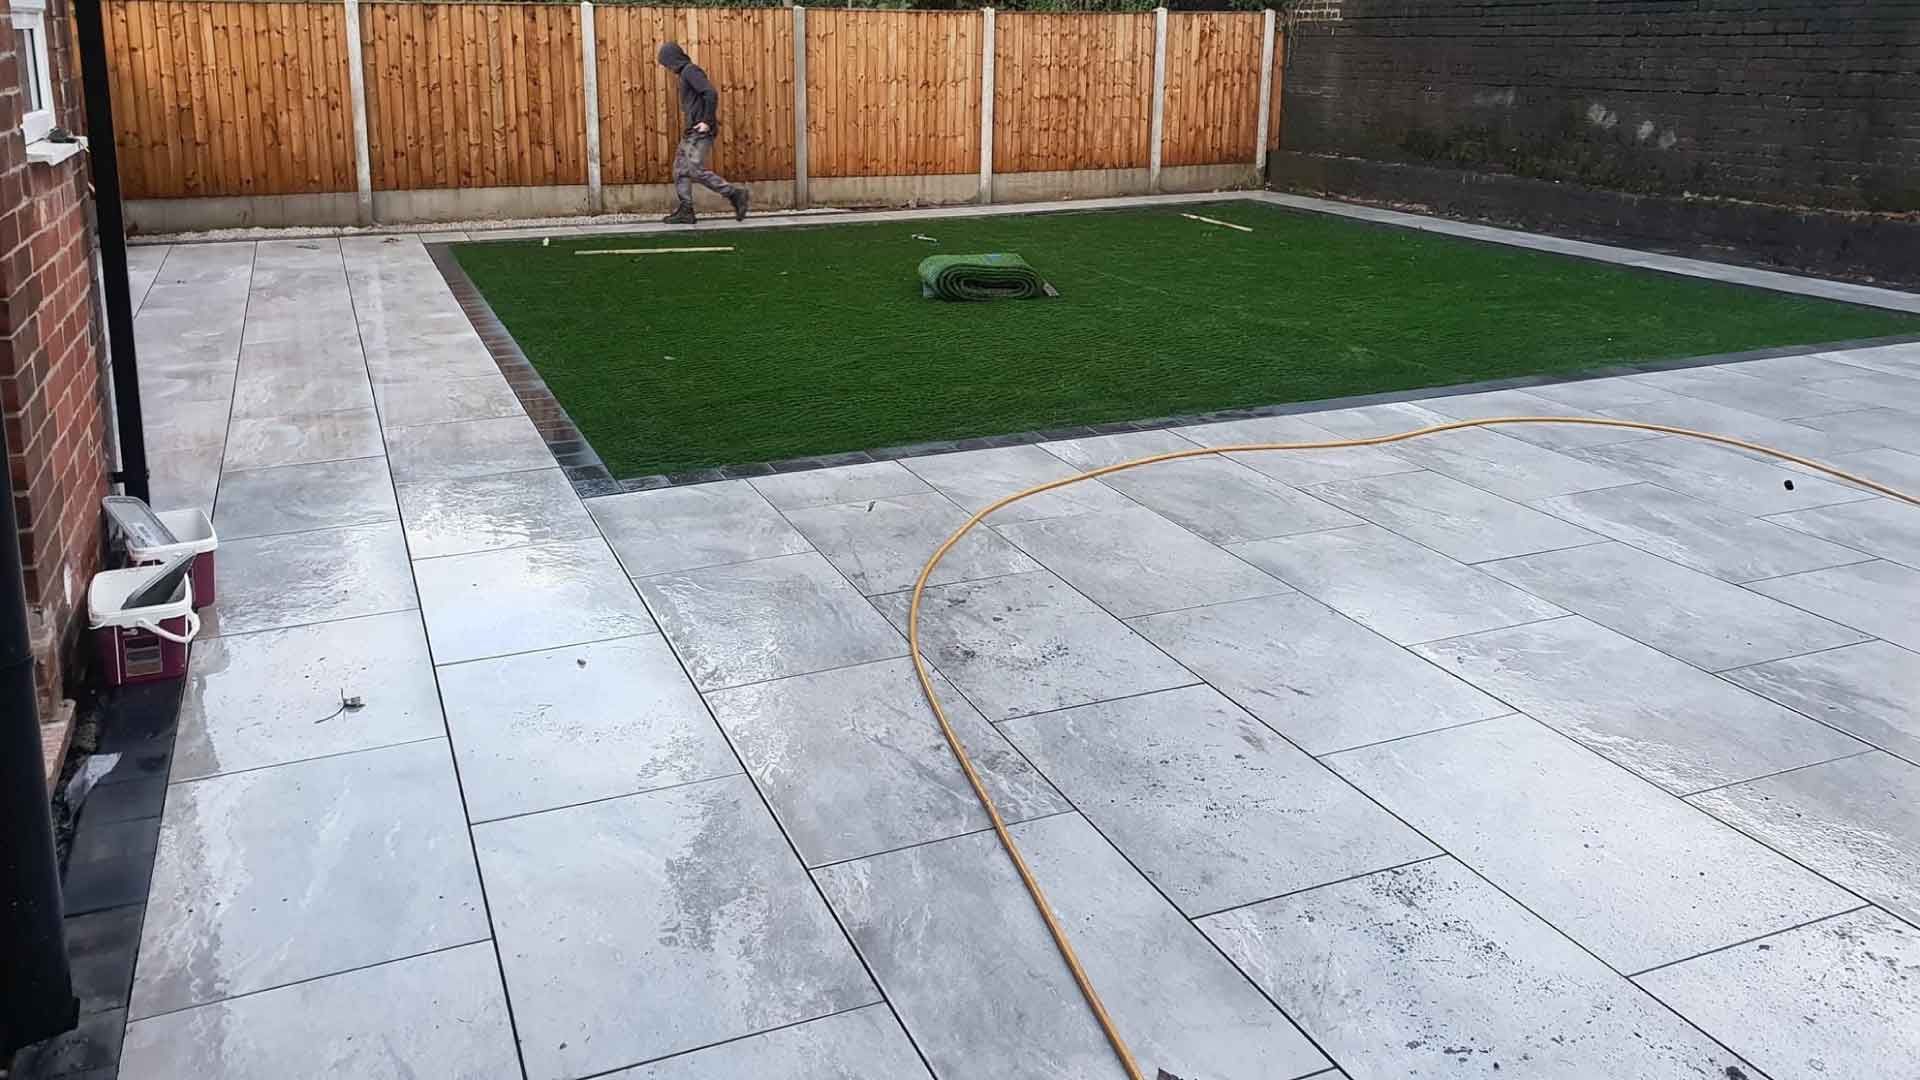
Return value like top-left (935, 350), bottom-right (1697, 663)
top-left (993, 13), bottom-right (1154, 173)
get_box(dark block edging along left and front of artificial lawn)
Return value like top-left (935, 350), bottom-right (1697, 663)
top-left (426, 235), bottom-right (1920, 498)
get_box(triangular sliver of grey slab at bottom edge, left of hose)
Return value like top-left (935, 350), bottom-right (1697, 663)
top-left (607, 1005), bottom-right (929, 1080)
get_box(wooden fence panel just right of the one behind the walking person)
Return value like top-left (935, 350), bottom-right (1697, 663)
top-left (806, 8), bottom-right (981, 177)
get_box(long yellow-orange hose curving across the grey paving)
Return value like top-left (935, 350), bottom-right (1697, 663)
top-left (906, 417), bottom-right (1920, 1080)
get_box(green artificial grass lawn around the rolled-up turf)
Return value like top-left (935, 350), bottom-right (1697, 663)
top-left (455, 202), bottom-right (1920, 477)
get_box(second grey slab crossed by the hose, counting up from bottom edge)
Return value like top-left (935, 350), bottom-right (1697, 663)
top-left (707, 657), bottom-right (1073, 867)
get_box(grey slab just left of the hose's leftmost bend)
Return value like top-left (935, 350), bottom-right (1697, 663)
top-left (637, 552), bottom-right (906, 690)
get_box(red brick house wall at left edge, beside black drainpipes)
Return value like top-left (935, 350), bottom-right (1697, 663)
top-left (0, 0), bottom-right (108, 699)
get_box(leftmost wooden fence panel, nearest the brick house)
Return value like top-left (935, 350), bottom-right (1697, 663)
top-left (104, 0), bottom-right (353, 198)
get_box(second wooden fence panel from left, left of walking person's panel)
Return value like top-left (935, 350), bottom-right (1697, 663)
top-left (361, 0), bottom-right (588, 190)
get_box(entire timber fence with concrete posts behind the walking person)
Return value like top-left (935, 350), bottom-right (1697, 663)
top-left (106, 0), bottom-right (1283, 231)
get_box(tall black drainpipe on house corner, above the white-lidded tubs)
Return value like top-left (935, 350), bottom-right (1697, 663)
top-left (73, 0), bottom-right (152, 502)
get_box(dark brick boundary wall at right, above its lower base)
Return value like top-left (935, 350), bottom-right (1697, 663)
top-left (1283, 0), bottom-right (1920, 211)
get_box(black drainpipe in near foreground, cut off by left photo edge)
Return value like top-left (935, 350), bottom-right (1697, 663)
top-left (0, 418), bottom-right (81, 1068)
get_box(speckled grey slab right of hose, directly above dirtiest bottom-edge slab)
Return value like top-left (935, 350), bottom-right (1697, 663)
top-left (1004, 686), bottom-right (1440, 917)
